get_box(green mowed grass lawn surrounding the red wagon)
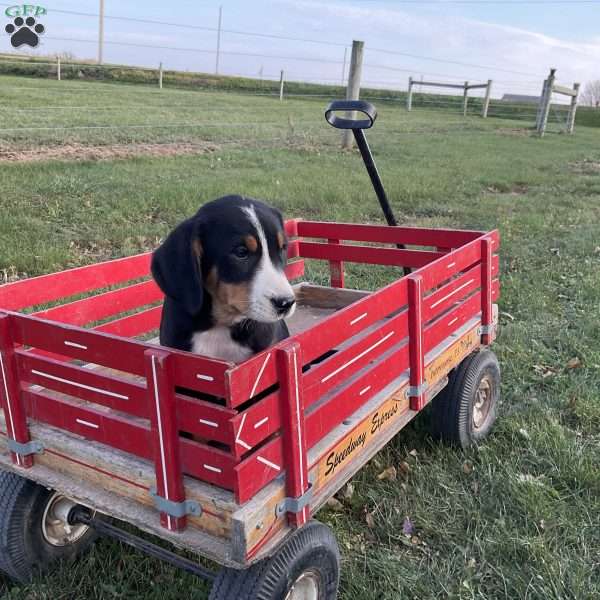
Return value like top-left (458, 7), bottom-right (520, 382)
top-left (0, 77), bottom-right (600, 600)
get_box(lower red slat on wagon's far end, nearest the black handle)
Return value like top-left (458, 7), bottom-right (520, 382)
top-left (300, 242), bottom-right (444, 268)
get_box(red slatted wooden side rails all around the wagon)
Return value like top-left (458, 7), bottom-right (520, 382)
top-left (0, 221), bottom-right (499, 531)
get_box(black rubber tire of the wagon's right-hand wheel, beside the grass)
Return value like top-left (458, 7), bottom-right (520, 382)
top-left (431, 348), bottom-right (500, 448)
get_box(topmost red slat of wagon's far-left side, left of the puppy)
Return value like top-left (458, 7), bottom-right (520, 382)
top-left (0, 252), bottom-right (150, 310)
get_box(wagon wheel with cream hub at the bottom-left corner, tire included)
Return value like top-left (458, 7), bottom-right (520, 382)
top-left (0, 471), bottom-right (96, 582)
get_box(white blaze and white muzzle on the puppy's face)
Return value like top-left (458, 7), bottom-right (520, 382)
top-left (242, 206), bottom-right (294, 321)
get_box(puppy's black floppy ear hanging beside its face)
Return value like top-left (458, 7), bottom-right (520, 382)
top-left (151, 217), bottom-right (204, 315)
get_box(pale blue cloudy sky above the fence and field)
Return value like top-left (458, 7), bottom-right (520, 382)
top-left (0, 0), bottom-right (600, 96)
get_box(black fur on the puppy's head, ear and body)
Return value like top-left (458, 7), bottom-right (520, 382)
top-left (151, 196), bottom-right (289, 353)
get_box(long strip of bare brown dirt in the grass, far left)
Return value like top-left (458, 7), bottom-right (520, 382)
top-left (0, 142), bottom-right (218, 162)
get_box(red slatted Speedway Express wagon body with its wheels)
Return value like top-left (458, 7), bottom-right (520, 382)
top-left (0, 101), bottom-right (499, 600)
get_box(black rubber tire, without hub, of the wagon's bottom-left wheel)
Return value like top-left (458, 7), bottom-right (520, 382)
top-left (0, 471), bottom-right (96, 583)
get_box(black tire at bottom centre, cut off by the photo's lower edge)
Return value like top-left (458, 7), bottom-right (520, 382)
top-left (209, 521), bottom-right (340, 600)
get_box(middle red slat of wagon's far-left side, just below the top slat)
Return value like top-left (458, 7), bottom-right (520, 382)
top-left (34, 280), bottom-right (163, 325)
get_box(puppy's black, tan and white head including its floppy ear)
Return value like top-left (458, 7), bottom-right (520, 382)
top-left (152, 196), bottom-right (295, 324)
